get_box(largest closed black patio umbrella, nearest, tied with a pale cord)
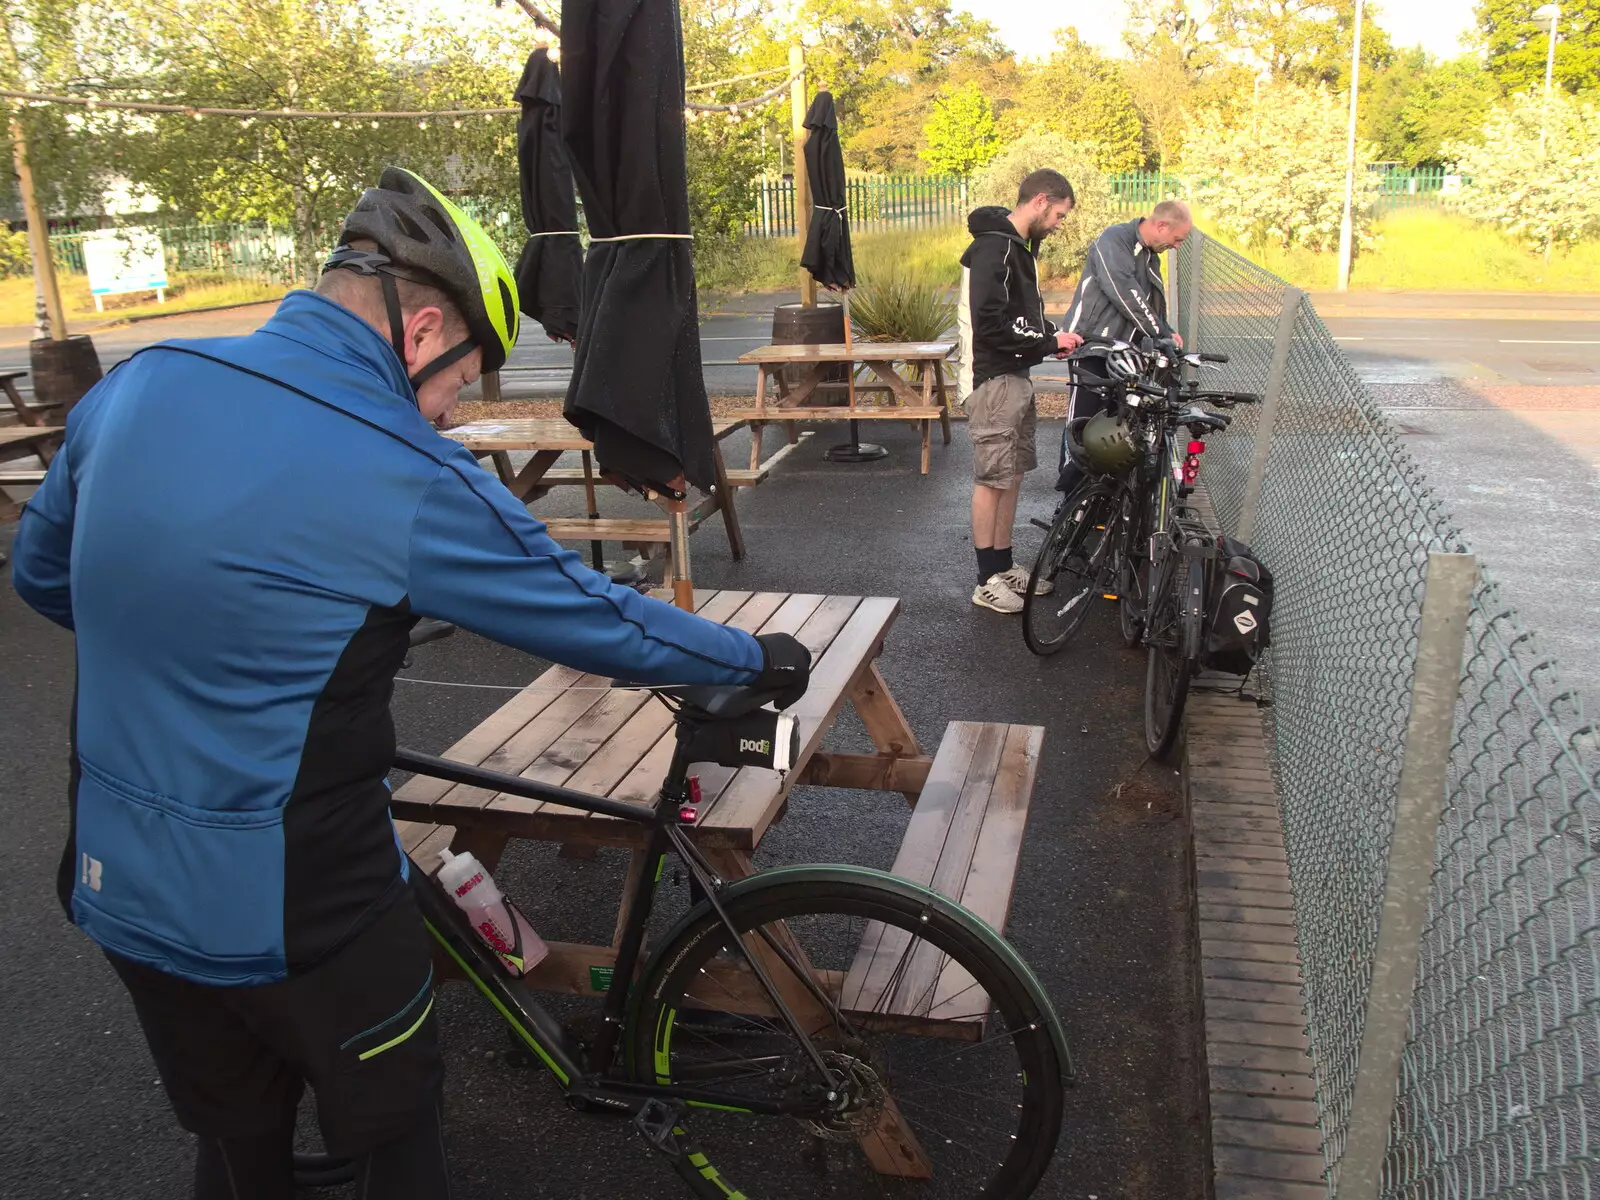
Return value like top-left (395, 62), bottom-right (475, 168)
top-left (562, 0), bottom-right (715, 491)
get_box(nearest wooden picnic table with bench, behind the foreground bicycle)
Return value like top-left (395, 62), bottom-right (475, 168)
top-left (392, 590), bottom-right (1043, 1038)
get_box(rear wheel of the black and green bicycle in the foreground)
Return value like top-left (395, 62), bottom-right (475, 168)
top-left (632, 872), bottom-right (1066, 1200)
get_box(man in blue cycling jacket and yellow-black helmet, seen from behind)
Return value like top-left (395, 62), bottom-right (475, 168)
top-left (13, 168), bottom-right (810, 1200)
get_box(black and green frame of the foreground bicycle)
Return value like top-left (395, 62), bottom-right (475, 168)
top-left (394, 738), bottom-right (848, 1115)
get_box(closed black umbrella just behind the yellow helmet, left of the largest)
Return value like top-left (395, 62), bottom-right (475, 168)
top-left (517, 48), bottom-right (584, 342)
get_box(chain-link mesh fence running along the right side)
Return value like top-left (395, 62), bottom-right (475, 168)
top-left (1173, 235), bottom-right (1600, 1200)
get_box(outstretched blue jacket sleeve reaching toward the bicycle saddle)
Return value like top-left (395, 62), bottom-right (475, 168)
top-left (408, 462), bottom-right (763, 683)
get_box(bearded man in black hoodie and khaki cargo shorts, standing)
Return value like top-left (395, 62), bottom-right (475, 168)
top-left (960, 170), bottom-right (1083, 613)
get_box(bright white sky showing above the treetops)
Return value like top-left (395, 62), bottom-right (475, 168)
top-left (955, 0), bottom-right (1475, 58)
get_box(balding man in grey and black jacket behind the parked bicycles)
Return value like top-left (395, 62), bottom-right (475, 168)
top-left (1056, 200), bottom-right (1194, 491)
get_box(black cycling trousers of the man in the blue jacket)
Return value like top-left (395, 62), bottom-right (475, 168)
top-left (106, 891), bottom-right (450, 1200)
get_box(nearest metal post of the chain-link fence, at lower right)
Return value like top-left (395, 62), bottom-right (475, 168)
top-left (1336, 554), bottom-right (1478, 1200)
